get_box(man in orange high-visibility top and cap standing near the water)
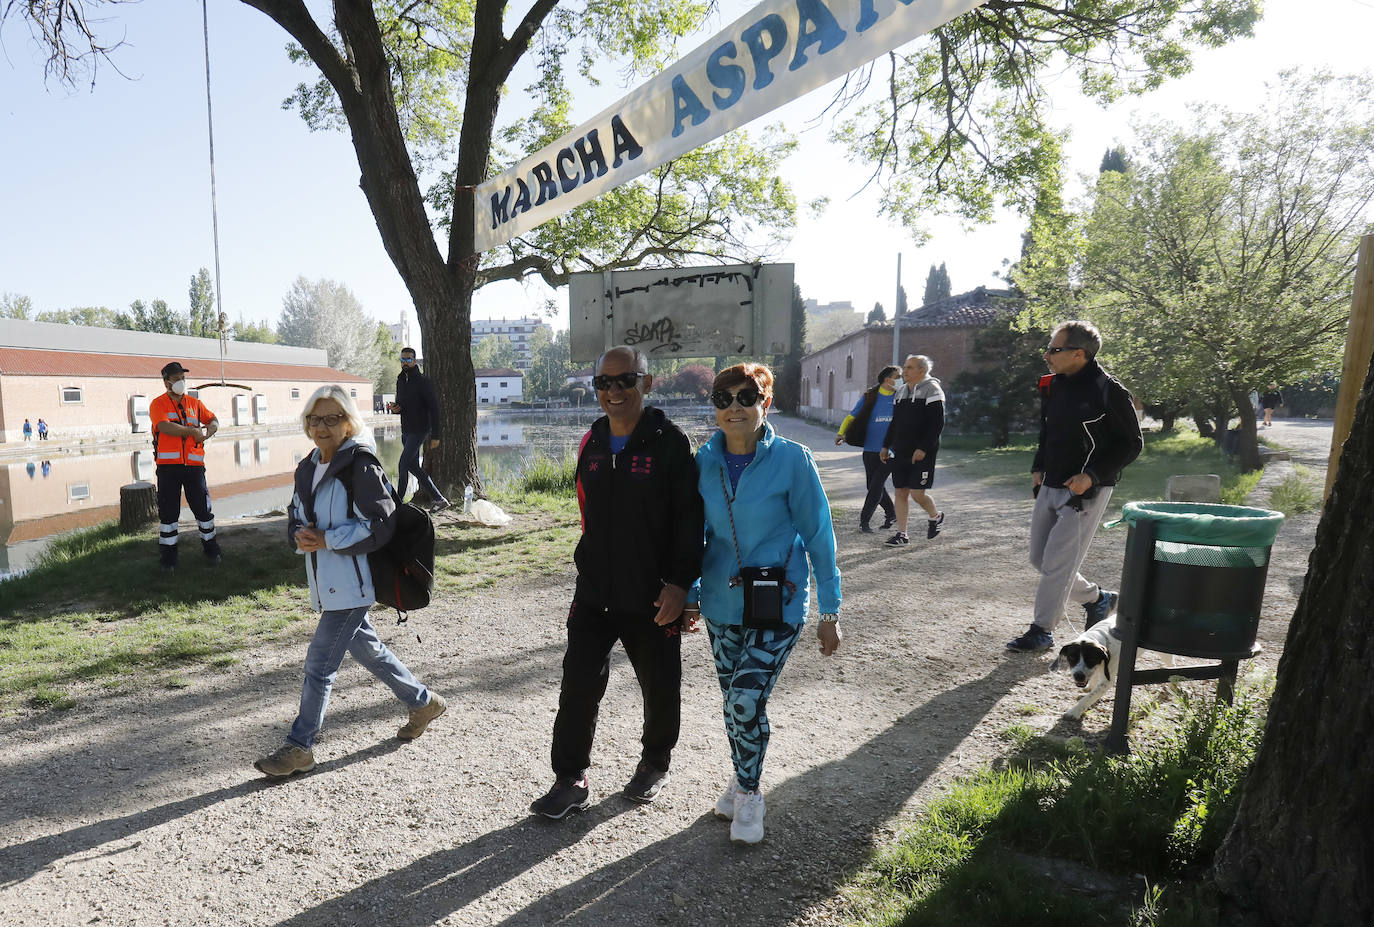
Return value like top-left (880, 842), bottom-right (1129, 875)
top-left (148, 361), bottom-right (220, 573)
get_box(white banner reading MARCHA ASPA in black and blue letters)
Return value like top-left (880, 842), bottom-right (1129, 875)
top-left (474, 0), bottom-right (984, 251)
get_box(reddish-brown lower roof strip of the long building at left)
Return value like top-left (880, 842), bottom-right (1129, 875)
top-left (0, 347), bottom-right (371, 385)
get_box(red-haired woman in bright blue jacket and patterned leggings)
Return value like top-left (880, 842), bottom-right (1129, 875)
top-left (687, 364), bottom-right (841, 843)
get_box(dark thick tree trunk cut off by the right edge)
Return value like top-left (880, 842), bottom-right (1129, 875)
top-left (1215, 351), bottom-right (1374, 927)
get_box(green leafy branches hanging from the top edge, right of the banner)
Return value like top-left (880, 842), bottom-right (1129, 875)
top-left (837, 0), bottom-right (1260, 232)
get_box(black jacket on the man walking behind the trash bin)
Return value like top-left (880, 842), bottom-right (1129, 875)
top-left (1031, 360), bottom-right (1145, 488)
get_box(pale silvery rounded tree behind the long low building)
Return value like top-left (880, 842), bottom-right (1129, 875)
top-left (276, 277), bottom-right (381, 380)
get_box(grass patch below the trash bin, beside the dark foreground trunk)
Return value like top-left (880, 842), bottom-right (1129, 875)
top-left (844, 680), bottom-right (1272, 927)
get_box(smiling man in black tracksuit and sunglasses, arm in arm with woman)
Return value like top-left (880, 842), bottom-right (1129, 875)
top-left (530, 347), bottom-right (703, 820)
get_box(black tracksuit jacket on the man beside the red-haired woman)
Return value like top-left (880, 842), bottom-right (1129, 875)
top-left (573, 407), bottom-right (705, 615)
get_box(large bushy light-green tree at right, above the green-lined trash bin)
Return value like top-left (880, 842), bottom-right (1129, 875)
top-left (1025, 73), bottom-right (1374, 468)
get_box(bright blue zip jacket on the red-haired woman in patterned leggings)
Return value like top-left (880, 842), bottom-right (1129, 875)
top-left (688, 420), bottom-right (840, 625)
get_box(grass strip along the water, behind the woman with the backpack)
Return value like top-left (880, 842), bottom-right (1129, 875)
top-left (0, 486), bottom-right (580, 713)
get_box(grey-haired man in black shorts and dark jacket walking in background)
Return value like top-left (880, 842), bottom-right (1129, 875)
top-left (882, 354), bottom-right (944, 547)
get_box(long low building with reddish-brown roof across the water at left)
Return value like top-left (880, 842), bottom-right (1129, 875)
top-left (0, 319), bottom-right (372, 442)
